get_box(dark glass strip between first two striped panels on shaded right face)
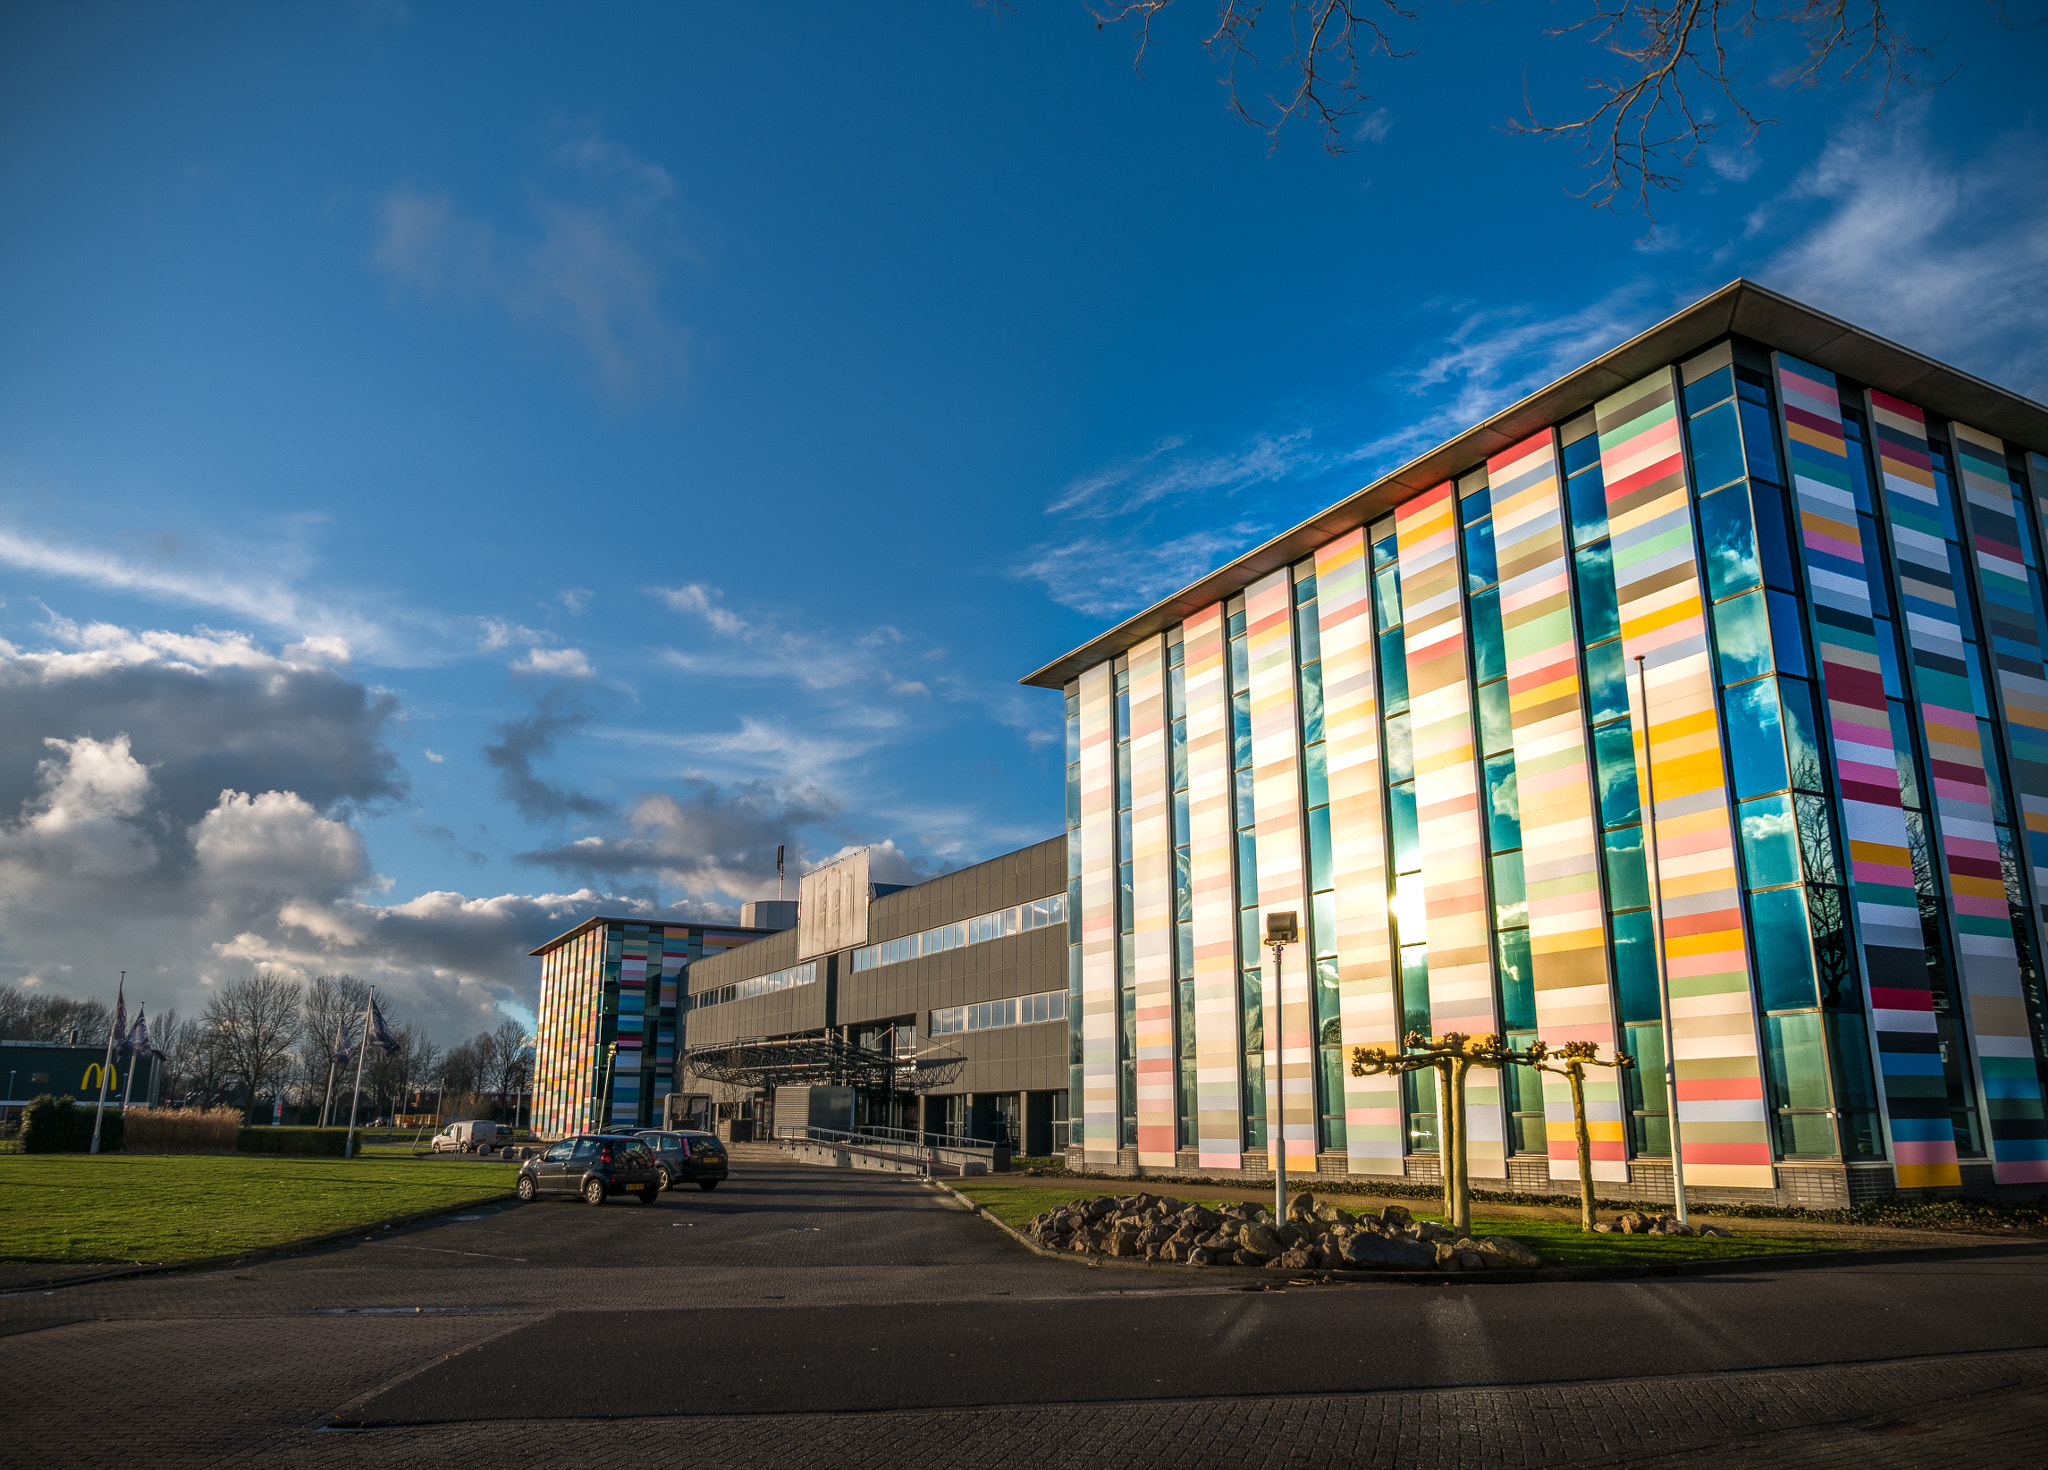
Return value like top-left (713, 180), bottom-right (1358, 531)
top-left (1841, 405), bottom-right (1985, 1159)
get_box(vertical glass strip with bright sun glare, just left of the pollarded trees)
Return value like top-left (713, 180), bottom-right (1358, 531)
top-left (1366, 516), bottom-right (1438, 1153)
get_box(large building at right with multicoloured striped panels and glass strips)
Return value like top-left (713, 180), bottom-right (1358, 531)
top-left (1026, 280), bottom-right (2048, 1204)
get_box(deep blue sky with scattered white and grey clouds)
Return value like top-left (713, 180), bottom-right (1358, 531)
top-left (0, 0), bottom-right (2048, 1038)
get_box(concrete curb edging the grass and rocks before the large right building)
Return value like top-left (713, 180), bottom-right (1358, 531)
top-left (928, 1179), bottom-right (2048, 1286)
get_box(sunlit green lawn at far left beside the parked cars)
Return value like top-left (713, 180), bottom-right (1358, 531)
top-left (0, 1153), bottom-right (516, 1263)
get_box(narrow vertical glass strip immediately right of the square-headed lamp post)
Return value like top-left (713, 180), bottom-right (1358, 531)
top-left (1294, 559), bottom-right (1346, 1151)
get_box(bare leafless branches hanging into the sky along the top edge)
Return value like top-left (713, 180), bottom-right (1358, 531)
top-left (1094, 0), bottom-right (1974, 215)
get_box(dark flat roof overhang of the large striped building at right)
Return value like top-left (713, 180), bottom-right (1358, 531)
top-left (1018, 278), bottom-right (2048, 690)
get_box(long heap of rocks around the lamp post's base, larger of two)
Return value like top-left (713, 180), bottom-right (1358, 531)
top-left (1024, 1194), bottom-right (1542, 1271)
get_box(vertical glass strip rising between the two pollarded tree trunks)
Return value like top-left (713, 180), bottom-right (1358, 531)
top-left (1458, 475), bottom-right (1550, 1155)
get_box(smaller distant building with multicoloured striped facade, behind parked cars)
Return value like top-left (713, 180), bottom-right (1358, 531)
top-left (532, 917), bottom-right (770, 1138)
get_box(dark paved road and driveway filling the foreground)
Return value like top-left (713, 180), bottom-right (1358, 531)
top-left (0, 1165), bottom-right (2048, 1470)
